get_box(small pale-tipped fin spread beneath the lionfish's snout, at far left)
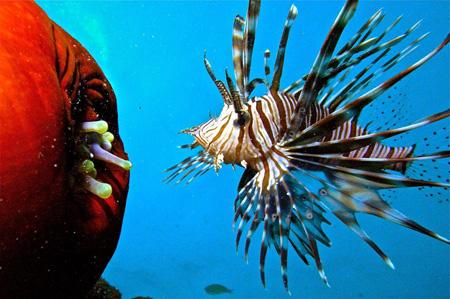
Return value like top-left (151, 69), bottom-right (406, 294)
top-left (163, 151), bottom-right (215, 184)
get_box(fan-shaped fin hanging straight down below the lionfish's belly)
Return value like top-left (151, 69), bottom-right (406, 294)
top-left (234, 162), bottom-right (331, 290)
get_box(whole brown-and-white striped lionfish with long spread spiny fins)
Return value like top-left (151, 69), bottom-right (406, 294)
top-left (166, 0), bottom-right (450, 290)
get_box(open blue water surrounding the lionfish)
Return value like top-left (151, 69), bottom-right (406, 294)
top-left (39, 0), bottom-right (450, 299)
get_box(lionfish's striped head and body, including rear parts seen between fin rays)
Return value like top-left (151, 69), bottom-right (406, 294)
top-left (191, 92), bottom-right (414, 176)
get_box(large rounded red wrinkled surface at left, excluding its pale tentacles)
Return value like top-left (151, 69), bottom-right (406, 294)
top-left (0, 2), bottom-right (129, 298)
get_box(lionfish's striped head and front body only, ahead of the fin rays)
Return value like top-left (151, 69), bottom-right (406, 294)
top-left (192, 93), bottom-right (296, 169)
